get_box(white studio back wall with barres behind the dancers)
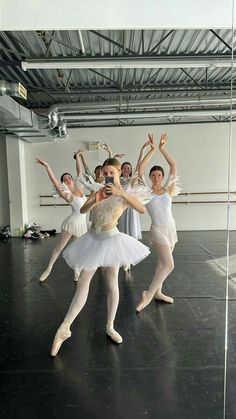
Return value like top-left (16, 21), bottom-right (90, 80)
top-left (21, 124), bottom-right (236, 235)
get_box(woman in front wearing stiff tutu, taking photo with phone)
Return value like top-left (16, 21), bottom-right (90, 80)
top-left (51, 158), bottom-right (150, 356)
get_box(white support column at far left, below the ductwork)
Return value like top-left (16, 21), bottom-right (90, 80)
top-left (6, 135), bottom-right (28, 237)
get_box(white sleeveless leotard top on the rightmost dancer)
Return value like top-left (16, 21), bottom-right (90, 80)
top-left (146, 192), bottom-right (174, 225)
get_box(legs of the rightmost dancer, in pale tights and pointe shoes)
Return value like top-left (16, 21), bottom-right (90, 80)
top-left (136, 243), bottom-right (174, 311)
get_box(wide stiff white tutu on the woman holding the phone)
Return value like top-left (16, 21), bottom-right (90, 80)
top-left (63, 228), bottom-right (150, 271)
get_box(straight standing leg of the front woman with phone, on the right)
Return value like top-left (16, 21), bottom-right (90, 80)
top-left (106, 266), bottom-right (123, 343)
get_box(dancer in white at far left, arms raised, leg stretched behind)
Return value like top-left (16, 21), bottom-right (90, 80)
top-left (35, 149), bottom-right (87, 282)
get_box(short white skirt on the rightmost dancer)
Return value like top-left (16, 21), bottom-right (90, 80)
top-left (150, 220), bottom-right (178, 250)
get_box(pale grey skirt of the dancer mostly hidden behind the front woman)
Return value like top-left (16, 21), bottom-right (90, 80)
top-left (118, 207), bottom-right (142, 239)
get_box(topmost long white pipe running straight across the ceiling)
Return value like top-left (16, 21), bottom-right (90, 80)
top-left (21, 55), bottom-right (236, 71)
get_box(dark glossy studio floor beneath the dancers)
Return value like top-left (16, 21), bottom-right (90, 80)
top-left (0, 231), bottom-right (236, 419)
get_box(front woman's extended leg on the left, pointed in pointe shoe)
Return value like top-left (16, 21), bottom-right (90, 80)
top-left (51, 270), bottom-right (95, 356)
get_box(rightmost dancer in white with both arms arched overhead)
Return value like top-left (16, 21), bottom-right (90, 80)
top-left (137, 134), bottom-right (178, 311)
